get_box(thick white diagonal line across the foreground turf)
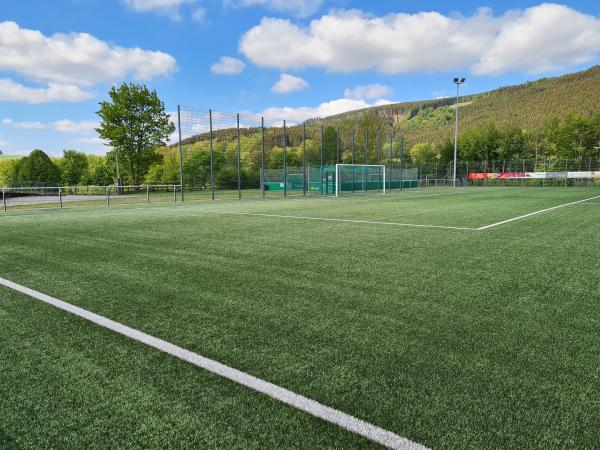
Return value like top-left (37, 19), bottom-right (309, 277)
top-left (0, 278), bottom-right (427, 450)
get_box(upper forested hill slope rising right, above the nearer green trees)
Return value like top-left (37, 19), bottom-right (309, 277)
top-left (324, 66), bottom-right (600, 143)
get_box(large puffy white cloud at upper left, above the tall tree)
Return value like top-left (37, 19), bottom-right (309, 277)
top-left (0, 22), bottom-right (175, 88)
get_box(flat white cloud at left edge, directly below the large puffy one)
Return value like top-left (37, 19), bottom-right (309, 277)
top-left (0, 79), bottom-right (93, 104)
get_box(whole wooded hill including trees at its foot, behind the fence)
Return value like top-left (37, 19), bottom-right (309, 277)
top-left (158, 66), bottom-right (600, 184)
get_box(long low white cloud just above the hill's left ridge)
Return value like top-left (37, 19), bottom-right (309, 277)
top-left (262, 98), bottom-right (391, 122)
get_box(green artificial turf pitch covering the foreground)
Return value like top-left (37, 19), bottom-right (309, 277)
top-left (0, 188), bottom-right (600, 449)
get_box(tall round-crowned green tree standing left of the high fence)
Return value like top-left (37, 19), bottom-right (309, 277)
top-left (96, 83), bottom-right (175, 184)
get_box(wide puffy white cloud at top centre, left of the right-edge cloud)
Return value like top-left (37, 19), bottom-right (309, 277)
top-left (240, 10), bottom-right (494, 73)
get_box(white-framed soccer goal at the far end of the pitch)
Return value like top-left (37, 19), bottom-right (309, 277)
top-left (335, 164), bottom-right (385, 197)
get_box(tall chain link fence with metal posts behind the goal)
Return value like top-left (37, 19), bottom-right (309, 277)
top-left (178, 106), bottom-right (418, 199)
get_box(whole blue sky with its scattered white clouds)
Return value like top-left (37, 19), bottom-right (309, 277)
top-left (0, 0), bottom-right (600, 155)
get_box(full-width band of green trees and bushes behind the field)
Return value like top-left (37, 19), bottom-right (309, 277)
top-left (0, 80), bottom-right (600, 187)
